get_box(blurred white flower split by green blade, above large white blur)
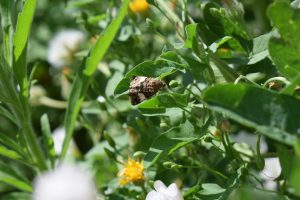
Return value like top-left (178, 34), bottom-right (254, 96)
top-left (52, 127), bottom-right (77, 155)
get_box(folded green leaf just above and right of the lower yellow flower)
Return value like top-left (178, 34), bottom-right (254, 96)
top-left (144, 121), bottom-right (199, 168)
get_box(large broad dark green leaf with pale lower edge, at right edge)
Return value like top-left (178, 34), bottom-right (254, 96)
top-left (203, 84), bottom-right (300, 145)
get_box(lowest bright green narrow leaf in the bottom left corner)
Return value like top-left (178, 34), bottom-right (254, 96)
top-left (0, 162), bottom-right (32, 192)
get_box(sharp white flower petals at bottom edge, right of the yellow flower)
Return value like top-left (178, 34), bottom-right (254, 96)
top-left (146, 180), bottom-right (183, 200)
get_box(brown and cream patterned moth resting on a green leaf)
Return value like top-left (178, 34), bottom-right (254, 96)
top-left (128, 76), bottom-right (166, 105)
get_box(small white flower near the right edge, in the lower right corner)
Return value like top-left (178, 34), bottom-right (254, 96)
top-left (260, 157), bottom-right (281, 190)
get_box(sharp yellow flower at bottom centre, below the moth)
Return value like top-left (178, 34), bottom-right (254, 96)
top-left (118, 158), bottom-right (145, 185)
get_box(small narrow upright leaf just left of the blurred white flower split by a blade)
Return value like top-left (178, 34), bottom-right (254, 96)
top-left (41, 114), bottom-right (56, 168)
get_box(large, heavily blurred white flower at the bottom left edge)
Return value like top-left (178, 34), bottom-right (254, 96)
top-left (32, 166), bottom-right (97, 200)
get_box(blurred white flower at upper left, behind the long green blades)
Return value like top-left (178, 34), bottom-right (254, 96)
top-left (48, 30), bottom-right (85, 68)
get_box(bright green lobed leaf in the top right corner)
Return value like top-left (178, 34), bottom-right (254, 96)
top-left (268, 1), bottom-right (300, 79)
